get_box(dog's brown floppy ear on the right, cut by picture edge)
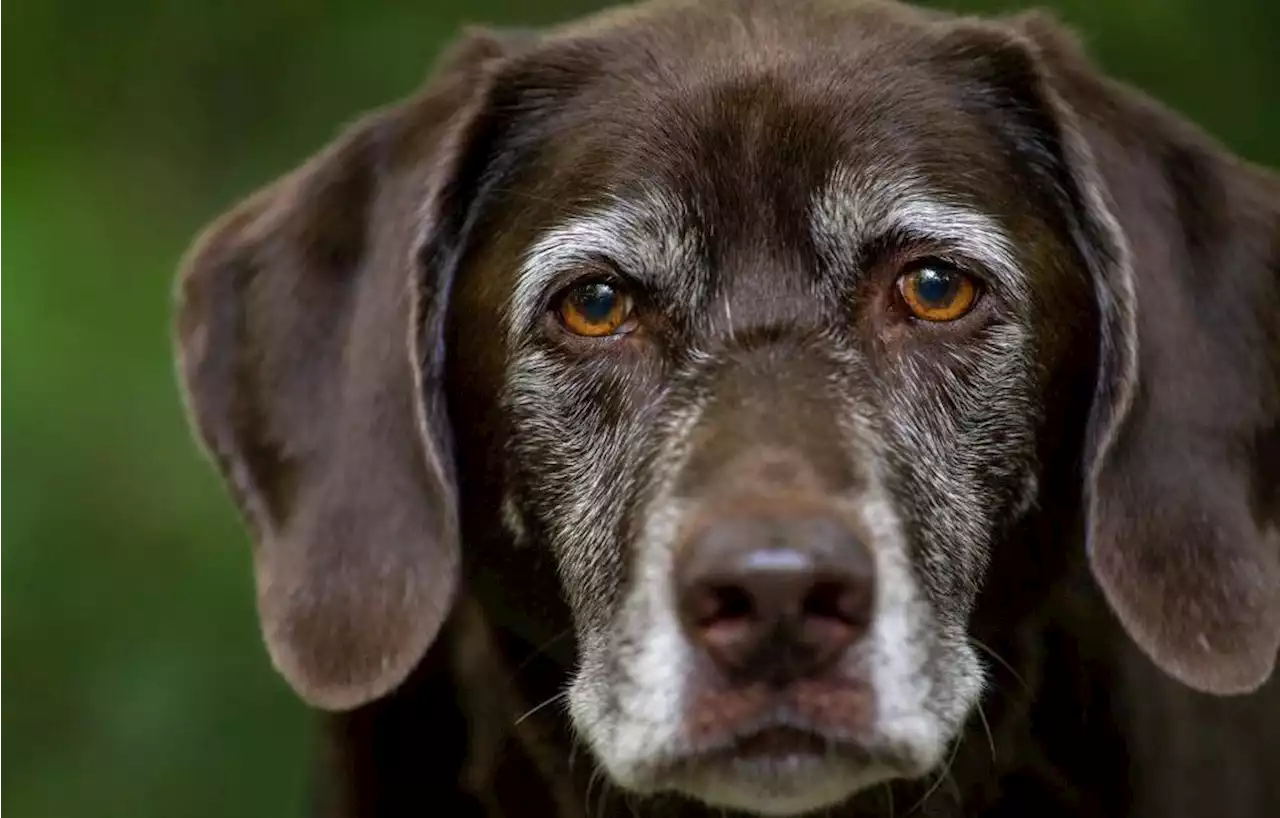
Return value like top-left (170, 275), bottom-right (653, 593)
top-left (952, 13), bottom-right (1280, 695)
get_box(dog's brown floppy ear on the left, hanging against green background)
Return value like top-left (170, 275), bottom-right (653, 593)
top-left (175, 31), bottom-right (534, 709)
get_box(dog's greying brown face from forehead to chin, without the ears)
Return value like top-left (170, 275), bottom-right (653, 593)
top-left (453, 28), bottom-right (1096, 813)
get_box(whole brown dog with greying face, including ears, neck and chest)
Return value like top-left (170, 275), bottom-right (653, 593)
top-left (175, 0), bottom-right (1280, 818)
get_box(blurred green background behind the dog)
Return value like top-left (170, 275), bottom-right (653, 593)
top-left (0, 0), bottom-right (1280, 818)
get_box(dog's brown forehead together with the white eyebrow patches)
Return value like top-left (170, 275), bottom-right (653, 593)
top-left (463, 0), bottom-right (1056, 343)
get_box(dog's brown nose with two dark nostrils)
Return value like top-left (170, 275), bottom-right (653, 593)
top-left (676, 515), bottom-right (874, 685)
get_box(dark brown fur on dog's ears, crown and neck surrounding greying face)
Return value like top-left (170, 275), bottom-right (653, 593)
top-left (177, 0), bottom-right (1280, 818)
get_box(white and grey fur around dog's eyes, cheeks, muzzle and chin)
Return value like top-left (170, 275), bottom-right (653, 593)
top-left (494, 158), bottom-right (1036, 814)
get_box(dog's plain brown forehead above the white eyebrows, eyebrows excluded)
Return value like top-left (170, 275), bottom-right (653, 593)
top-left (517, 3), bottom-right (1019, 252)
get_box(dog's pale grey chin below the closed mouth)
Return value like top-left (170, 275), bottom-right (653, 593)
top-left (614, 730), bottom-right (927, 815)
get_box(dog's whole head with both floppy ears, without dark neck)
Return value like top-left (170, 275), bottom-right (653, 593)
top-left (180, 3), bottom-right (1277, 814)
